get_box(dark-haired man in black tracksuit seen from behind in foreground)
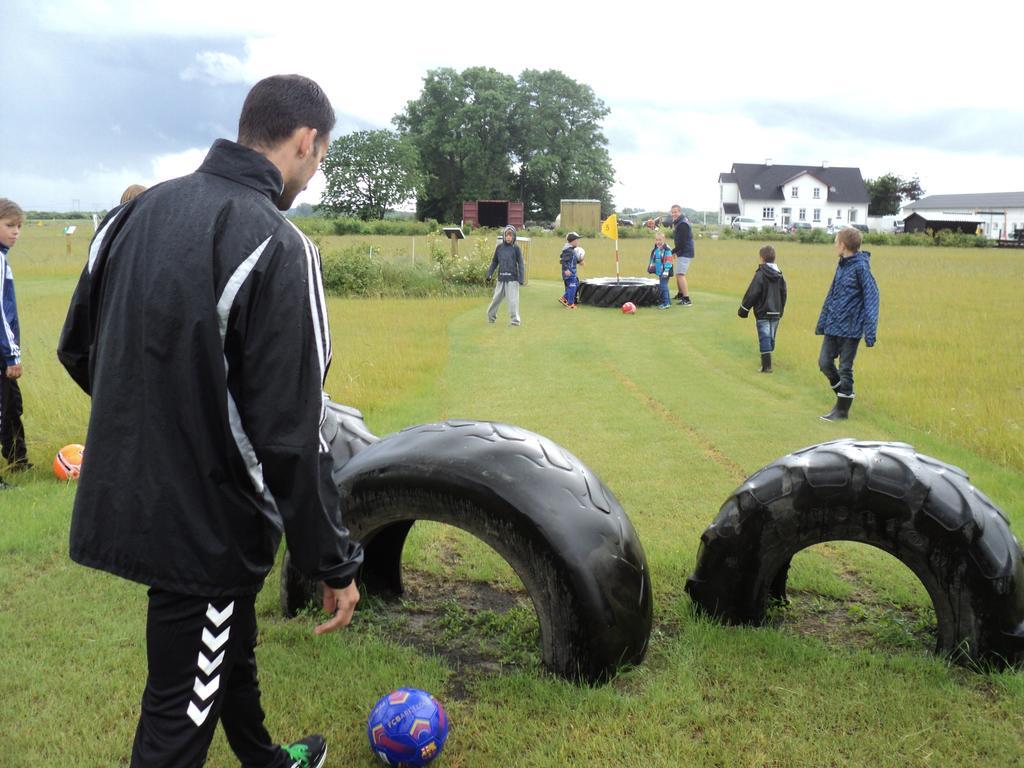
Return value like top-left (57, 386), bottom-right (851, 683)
top-left (58, 75), bottom-right (362, 768)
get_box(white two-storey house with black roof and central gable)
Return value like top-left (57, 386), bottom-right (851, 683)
top-left (718, 160), bottom-right (870, 227)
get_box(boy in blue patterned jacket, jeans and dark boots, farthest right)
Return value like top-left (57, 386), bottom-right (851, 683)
top-left (814, 227), bottom-right (879, 421)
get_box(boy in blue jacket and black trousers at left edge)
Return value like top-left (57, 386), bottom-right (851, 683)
top-left (0, 198), bottom-right (32, 489)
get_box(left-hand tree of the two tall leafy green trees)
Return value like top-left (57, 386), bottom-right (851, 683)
top-left (393, 67), bottom-right (516, 221)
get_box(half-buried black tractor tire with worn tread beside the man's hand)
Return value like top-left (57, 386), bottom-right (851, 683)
top-left (282, 409), bottom-right (652, 683)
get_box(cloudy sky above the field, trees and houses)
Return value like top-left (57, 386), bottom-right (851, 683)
top-left (0, 0), bottom-right (1024, 210)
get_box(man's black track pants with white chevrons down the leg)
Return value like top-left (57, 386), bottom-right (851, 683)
top-left (131, 588), bottom-right (289, 768)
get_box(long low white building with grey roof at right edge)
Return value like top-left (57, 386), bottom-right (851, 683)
top-left (902, 191), bottom-right (1024, 239)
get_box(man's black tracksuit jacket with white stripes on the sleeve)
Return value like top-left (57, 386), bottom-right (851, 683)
top-left (57, 139), bottom-right (362, 597)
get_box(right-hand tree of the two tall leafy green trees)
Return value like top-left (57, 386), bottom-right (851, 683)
top-left (513, 70), bottom-right (614, 219)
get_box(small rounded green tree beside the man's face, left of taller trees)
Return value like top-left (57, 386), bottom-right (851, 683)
top-left (321, 130), bottom-right (420, 221)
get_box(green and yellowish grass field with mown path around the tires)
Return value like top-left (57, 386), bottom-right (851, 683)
top-left (0, 219), bottom-right (1024, 768)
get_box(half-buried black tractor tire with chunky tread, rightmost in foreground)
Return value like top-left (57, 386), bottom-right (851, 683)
top-left (686, 439), bottom-right (1024, 666)
